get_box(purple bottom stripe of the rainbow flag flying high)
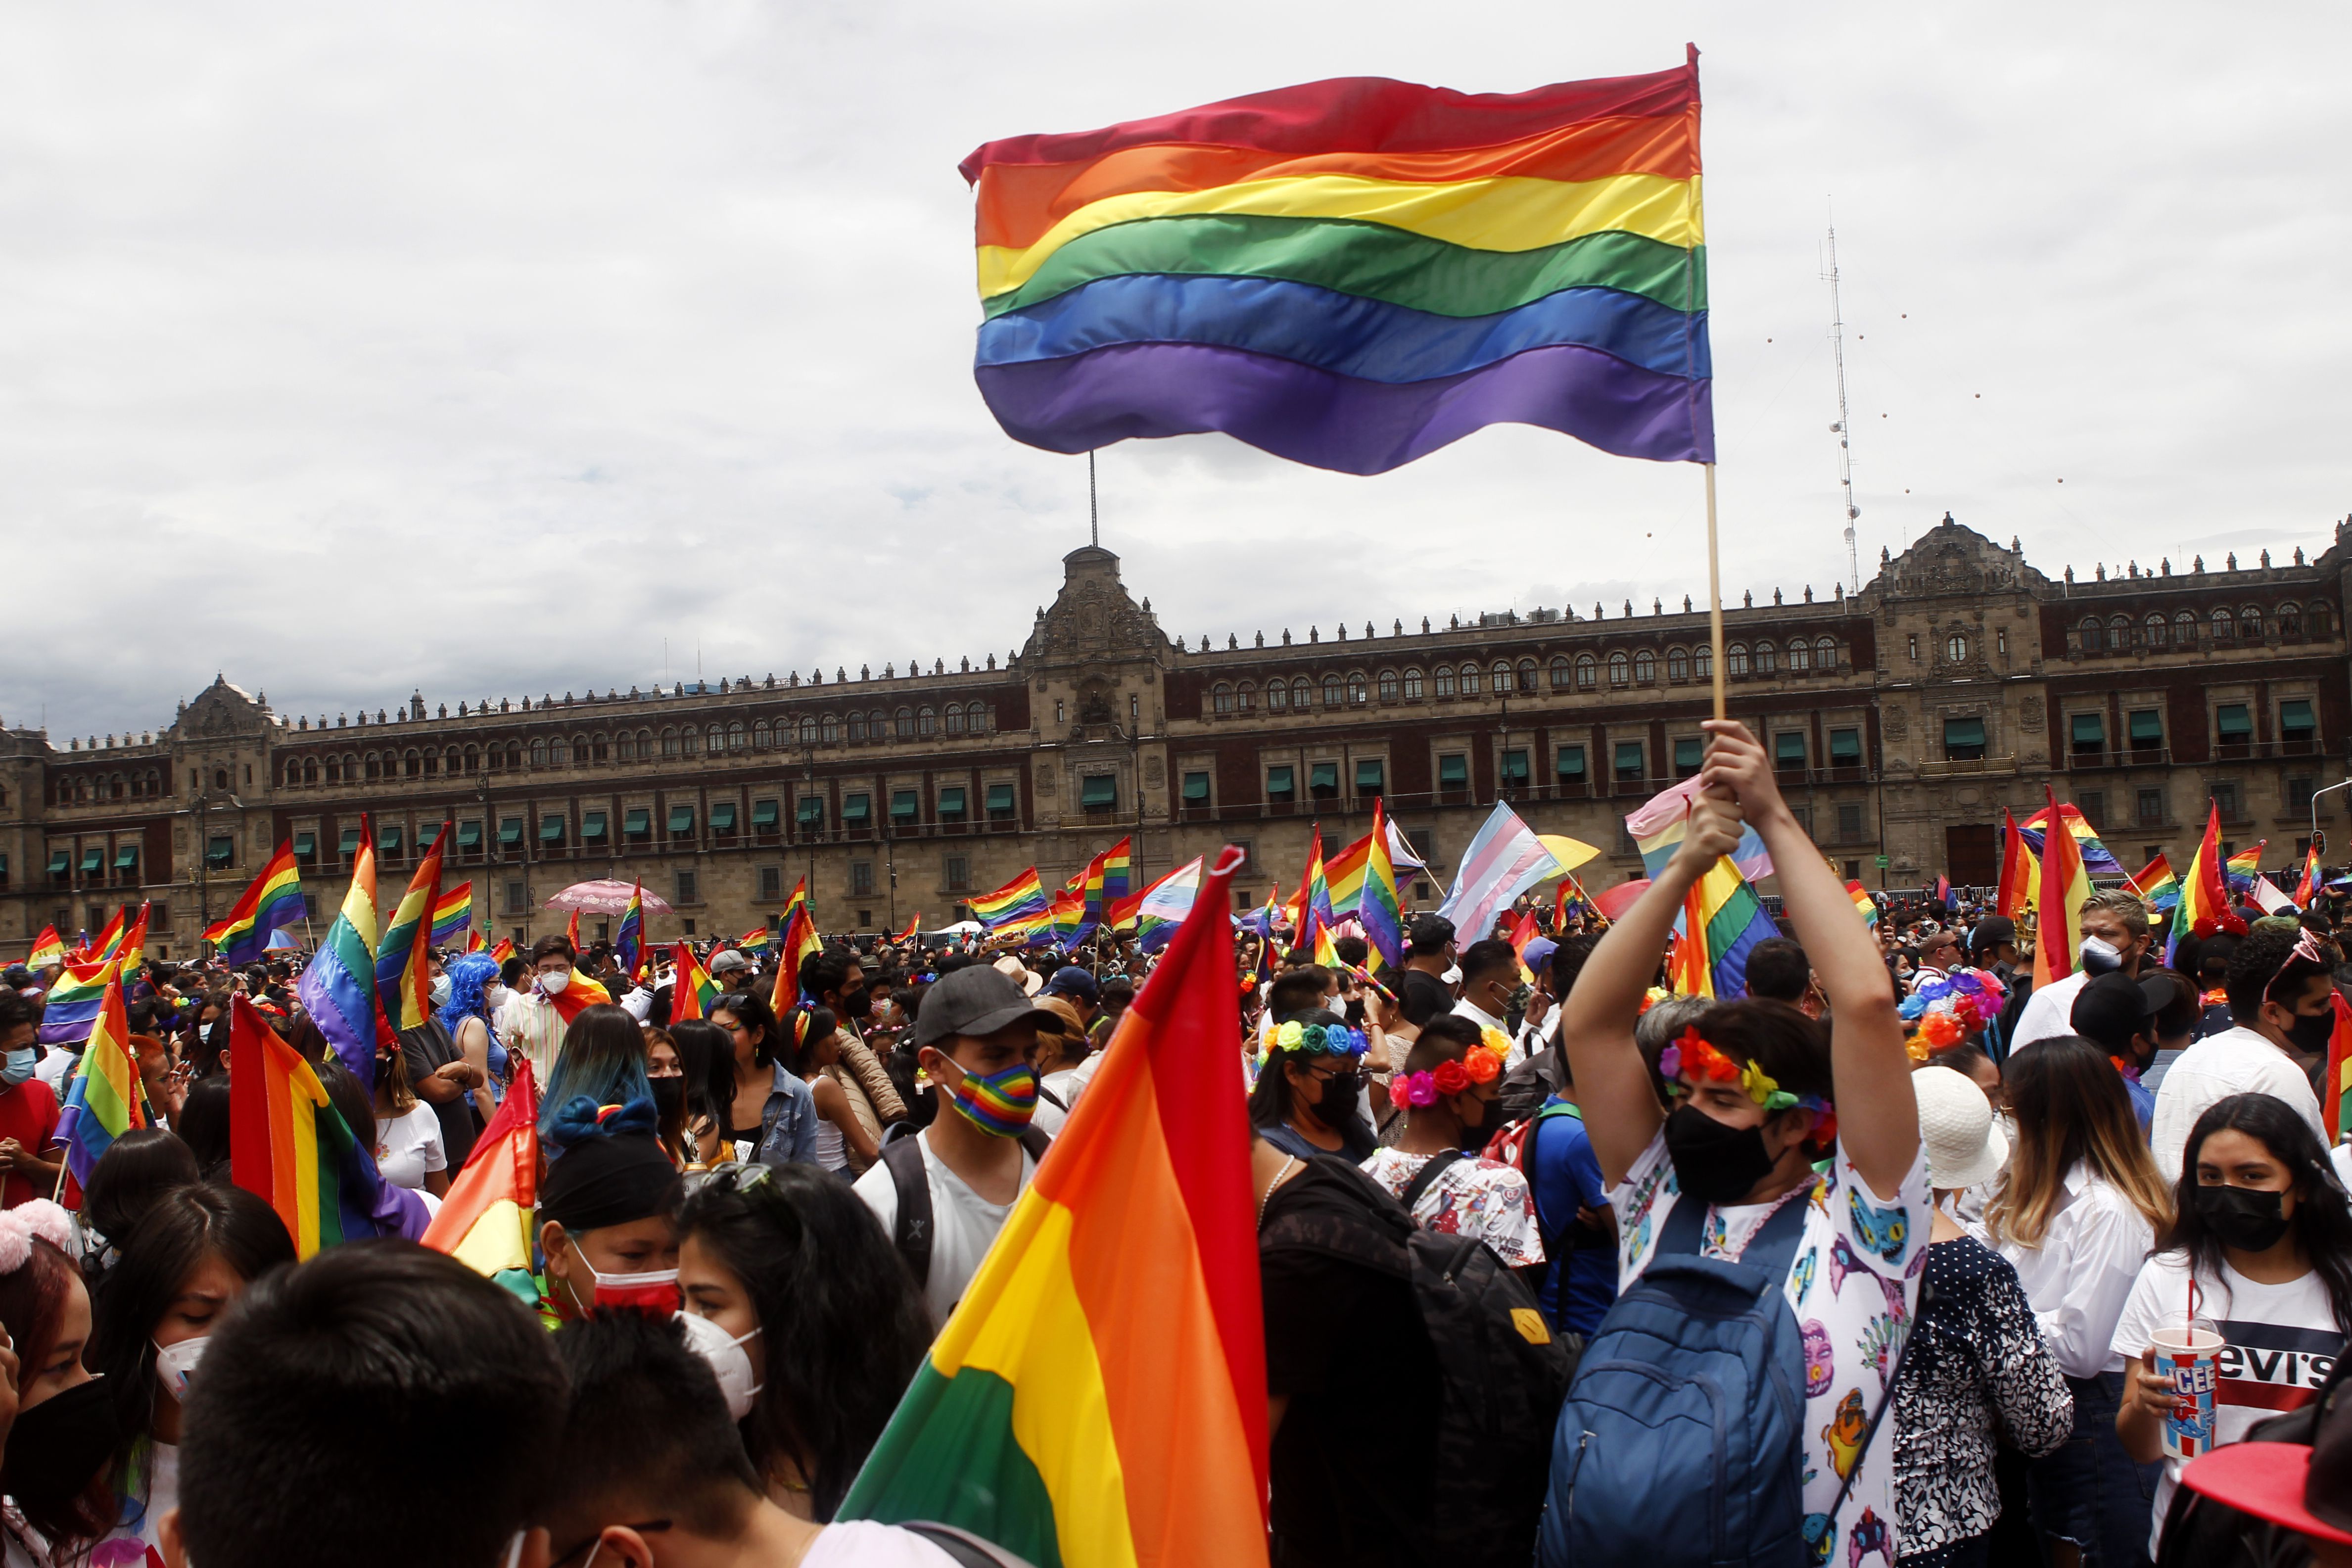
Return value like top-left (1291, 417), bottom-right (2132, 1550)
top-left (974, 343), bottom-right (1715, 475)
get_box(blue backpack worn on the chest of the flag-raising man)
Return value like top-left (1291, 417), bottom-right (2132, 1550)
top-left (1536, 1196), bottom-right (1806, 1568)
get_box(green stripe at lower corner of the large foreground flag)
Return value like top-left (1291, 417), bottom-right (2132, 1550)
top-left (837, 1361), bottom-right (1061, 1568)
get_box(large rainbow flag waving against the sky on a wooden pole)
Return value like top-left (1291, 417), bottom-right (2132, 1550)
top-left (962, 49), bottom-right (1715, 475)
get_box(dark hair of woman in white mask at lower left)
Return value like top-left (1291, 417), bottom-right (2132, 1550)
top-left (82, 1189), bottom-right (296, 1476)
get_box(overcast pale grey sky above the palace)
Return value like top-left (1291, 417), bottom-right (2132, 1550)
top-left (0, 0), bottom-right (2352, 745)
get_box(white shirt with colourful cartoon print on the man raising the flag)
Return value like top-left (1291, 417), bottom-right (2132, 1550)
top-left (1609, 1131), bottom-right (1931, 1563)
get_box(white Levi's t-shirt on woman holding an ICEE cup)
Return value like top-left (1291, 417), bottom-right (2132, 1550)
top-left (2115, 1253), bottom-right (2345, 1556)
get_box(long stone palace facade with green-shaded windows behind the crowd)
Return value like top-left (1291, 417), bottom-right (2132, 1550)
top-left (0, 517), bottom-right (2352, 957)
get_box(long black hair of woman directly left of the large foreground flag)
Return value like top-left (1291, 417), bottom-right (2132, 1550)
top-left (677, 1166), bottom-right (932, 1523)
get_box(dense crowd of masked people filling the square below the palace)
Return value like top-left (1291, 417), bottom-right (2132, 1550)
top-left (0, 724), bottom-right (2352, 1568)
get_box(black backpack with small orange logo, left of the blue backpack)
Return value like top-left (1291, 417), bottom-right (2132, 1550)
top-left (1266, 1154), bottom-right (1576, 1568)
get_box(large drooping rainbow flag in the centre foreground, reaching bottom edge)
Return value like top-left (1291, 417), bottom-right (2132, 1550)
top-left (840, 849), bottom-right (1266, 1568)
